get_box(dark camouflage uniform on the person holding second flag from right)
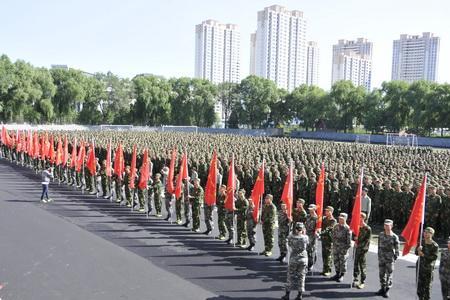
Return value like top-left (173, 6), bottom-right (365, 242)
top-left (353, 224), bottom-right (372, 284)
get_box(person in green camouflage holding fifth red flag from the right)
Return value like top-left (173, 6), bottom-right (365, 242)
top-left (260, 194), bottom-right (277, 256)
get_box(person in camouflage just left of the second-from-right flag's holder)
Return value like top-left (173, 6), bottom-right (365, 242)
top-left (331, 213), bottom-right (351, 282)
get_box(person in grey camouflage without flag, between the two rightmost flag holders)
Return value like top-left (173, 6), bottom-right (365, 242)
top-left (376, 219), bottom-right (399, 298)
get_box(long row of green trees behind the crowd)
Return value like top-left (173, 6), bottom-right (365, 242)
top-left (0, 55), bottom-right (450, 135)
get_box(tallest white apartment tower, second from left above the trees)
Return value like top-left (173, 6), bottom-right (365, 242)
top-left (250, 5), bottom-right (306, 91)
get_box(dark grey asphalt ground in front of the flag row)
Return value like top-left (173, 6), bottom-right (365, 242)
top-left (0, 159), bottom-right (441, 300)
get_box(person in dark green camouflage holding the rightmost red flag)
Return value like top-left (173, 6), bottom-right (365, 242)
top-left (416, 227), bottom-right (439, 300)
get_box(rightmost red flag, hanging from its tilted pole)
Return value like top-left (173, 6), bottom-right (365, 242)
top-left (402, 174), bottom-right (427, 255)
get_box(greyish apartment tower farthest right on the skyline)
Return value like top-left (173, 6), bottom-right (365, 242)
top-left (392, 32), bottom-right (440, 82)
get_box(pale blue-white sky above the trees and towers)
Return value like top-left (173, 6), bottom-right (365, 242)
top-left (0, 0), bottom-right (450, 90)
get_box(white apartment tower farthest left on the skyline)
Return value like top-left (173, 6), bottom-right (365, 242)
top-left (195, 20), bottom-right (241, 83)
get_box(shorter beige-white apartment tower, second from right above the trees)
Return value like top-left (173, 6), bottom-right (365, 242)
top-left (331, 38), bottom-right (373, 91)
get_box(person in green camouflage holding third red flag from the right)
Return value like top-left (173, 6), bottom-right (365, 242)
top-left (320, 206), bottom-right (337, 276)
